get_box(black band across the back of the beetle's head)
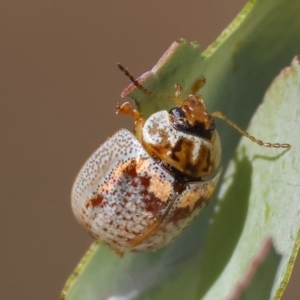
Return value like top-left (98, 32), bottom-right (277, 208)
top-left (169, 107), bottom-right (215, 140)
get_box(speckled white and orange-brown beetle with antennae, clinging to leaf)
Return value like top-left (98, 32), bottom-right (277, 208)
top-left (71, 65), bottom-right (290, 253)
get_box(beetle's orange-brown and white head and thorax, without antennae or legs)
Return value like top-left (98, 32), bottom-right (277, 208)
top-left (141, 95), bottom-right (220, 178)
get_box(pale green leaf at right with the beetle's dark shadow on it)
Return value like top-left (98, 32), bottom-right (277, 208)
top-left (200, 57), bottom-right (300, 299)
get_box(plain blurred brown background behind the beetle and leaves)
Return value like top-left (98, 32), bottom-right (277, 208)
top-left (0, 0), bottom-right (300, 300)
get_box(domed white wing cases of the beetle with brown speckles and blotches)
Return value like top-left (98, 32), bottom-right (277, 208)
top-left (71, 130), bottom-right (219, 252)
